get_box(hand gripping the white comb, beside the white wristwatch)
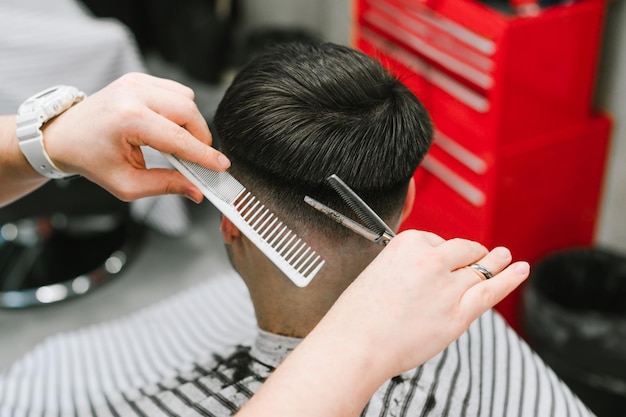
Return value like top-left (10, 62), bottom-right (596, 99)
top-left (44, 73), bottom-right (230, 202)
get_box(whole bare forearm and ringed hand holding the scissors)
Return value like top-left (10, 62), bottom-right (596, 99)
top-left (239, 230), bottom-right (530, 417)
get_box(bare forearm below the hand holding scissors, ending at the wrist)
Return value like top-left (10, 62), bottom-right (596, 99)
top-left (237, 316), bottom-right (380, 417)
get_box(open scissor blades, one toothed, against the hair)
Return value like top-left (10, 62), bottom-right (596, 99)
top-left (304, 174), bottom-right (396, 246)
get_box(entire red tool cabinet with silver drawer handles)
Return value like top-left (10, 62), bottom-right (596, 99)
top-left (353, 0), bottom-right (610, 331)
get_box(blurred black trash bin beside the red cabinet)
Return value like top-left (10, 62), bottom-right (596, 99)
top-left (523, 248), bottom-right (626, 417)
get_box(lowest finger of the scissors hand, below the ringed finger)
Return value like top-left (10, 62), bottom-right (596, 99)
top-left (460, 261), bottom-right (530, 319)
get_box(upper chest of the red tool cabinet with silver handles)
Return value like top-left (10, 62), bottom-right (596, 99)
top-left (354, 0), bottom-right (606, 151)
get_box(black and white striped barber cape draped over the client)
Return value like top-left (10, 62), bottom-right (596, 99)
top-left (0, 273), bottom-right (593, 417)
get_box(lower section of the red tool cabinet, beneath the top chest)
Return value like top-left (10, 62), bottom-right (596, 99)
top-left (403, 116), bottom-right (611, 256)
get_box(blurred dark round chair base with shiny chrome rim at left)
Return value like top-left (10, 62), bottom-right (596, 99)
top-left (0, 178), bottom-right (143, 308)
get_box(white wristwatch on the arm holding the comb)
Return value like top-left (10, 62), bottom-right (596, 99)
top-left (16, 85), bottom-right (86, 178)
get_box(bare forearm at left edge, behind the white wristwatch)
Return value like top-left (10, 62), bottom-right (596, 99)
top-left (0, 116), bottom-right (47, 207)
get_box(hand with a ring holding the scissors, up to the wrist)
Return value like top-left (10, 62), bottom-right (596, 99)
top-left (320, 230), bottom-right (530, 382)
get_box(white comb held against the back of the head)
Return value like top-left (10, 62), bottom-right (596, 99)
top-left (163, 154), bottom-right (324, 287)
